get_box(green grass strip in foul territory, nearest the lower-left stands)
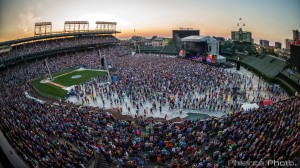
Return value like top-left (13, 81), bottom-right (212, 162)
top-left (31, 78), bottom-right (68, 99)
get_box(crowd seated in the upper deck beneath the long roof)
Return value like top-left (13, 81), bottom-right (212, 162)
top-left (0, 36), bottom-right (118, 62)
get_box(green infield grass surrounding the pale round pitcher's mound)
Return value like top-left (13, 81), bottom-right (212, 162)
top-left (53, 70), bottom-right (106, 86)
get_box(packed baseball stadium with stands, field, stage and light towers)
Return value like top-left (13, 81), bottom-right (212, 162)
top-left (0, 1), bottom-right (300, 168)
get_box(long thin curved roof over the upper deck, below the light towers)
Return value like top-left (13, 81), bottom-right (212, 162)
top-left (0, 31), bottom-right (121, 46)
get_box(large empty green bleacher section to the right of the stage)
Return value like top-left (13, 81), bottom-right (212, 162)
top-left (240, 55), bottom-right (287, 78)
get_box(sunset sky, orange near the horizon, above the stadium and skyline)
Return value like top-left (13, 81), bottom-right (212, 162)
top-left (0, 0), bottom-right (300, 45)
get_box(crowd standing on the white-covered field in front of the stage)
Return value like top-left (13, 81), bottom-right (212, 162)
top-left (68, 54), bottom-right (286, 117)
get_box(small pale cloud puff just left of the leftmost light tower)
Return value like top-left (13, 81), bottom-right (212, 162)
top-left (18, 9), bottom-right (41, 33)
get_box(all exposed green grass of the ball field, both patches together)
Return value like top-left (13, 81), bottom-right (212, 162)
top-left (31, 69), bottom-right (106, 99)
